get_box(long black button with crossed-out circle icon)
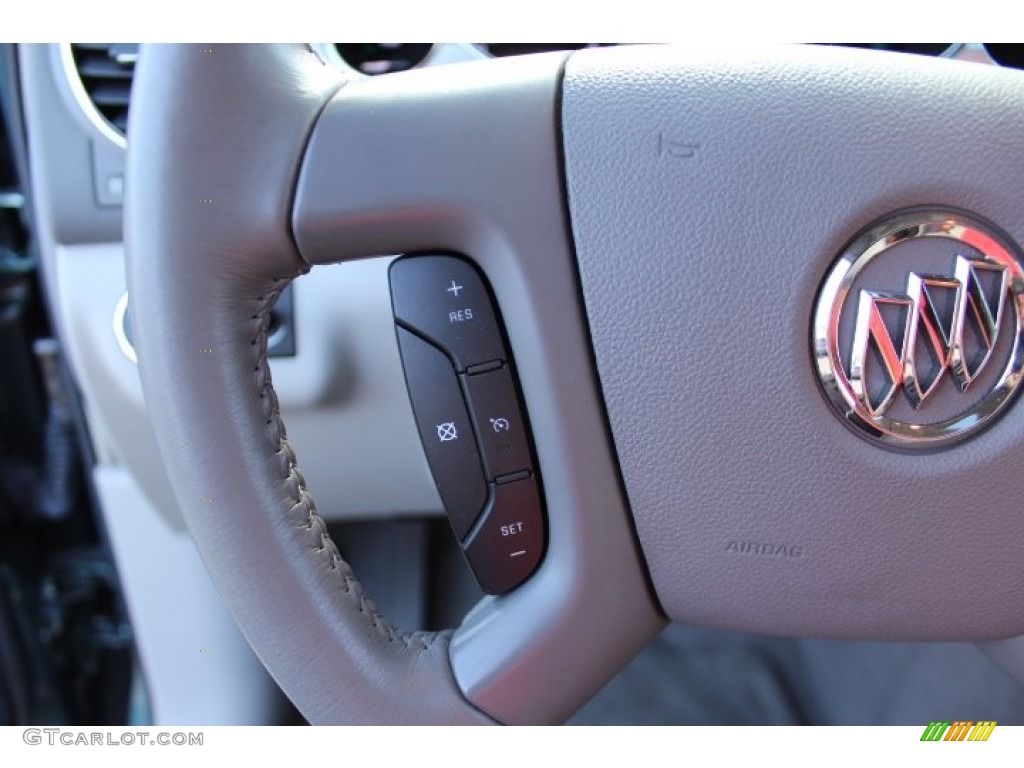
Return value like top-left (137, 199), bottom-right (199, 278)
top-left (397, 328), bottom-right (487, 540)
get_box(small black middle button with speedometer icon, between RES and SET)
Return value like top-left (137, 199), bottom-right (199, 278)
top-left (462, 366), bottom-right (532, 480)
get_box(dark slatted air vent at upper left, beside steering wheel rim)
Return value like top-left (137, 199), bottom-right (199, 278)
top-left (71, 43), bottom-right (138, 136)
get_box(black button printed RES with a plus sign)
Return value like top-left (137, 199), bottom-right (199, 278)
top-left (390, 256), bottom-right (505, 371)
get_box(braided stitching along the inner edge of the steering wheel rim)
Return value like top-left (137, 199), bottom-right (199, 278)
top-left (250, 278), bottom-right (440, 651)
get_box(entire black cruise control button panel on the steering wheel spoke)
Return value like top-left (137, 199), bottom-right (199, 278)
top-left (390, 255), bottom-right (546, 595)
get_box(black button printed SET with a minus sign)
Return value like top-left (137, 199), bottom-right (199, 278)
top-left (465, 477), bottom-right (544, 595)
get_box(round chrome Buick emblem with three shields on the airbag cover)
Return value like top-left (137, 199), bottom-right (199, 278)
top-left (813, 210), bottom-right (1024, 449)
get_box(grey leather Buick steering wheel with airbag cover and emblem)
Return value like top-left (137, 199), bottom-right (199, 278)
top-left (126, 45), bottom-right (1024, 724)
